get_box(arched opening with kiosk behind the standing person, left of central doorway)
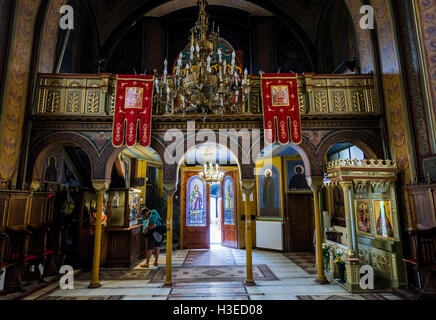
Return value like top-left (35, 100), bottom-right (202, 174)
top-left (106, 145), bottom-right (166, 268)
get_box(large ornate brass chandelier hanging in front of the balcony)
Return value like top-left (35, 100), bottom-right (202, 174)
top-left (154, 0), bottom-right (250, 118)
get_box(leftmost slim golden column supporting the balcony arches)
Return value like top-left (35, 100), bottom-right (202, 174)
top-left (88, 180), bottom-right (110, 289)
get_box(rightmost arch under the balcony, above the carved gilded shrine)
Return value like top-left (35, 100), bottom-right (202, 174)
top-left (318, 131), bottom-right (384, 170)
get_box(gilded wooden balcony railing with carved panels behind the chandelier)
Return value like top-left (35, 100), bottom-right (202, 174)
top-left (33, 74), bottom-right (380, 117)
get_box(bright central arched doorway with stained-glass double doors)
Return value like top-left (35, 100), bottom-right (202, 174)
top-left (179, 143), bottom-right (241, 249)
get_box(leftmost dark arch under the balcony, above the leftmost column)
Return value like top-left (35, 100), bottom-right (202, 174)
top-left (29, 132), bottom-right (98, 182)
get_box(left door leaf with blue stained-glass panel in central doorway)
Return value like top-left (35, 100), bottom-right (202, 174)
top-left (181, 171), bottom-right (210, 249)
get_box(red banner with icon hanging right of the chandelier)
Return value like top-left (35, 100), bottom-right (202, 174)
top-left (261, 74), bottom-right (303, 144)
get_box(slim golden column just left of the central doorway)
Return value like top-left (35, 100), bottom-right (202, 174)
top-left (164, 181), bottom-right (176, 287)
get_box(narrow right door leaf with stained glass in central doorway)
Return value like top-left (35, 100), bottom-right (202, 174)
top-left (221, 172), bottom-right (238, 249)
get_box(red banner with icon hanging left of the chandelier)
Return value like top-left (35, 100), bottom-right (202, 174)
top-left (112, 75), bottom-right (154, 147)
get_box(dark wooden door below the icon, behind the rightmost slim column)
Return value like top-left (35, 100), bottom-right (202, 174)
top-left (288, 193), bottom-right (314, 252)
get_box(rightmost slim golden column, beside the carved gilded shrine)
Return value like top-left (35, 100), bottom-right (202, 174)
top-left (309, 177), bottom-right (327, 284)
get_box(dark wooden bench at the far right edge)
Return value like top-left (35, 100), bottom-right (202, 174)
top-left (403, 227), bottom-right (436, 296)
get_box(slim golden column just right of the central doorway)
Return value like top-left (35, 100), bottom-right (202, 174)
top-left (242, 179), bottom-right (256, 286)
